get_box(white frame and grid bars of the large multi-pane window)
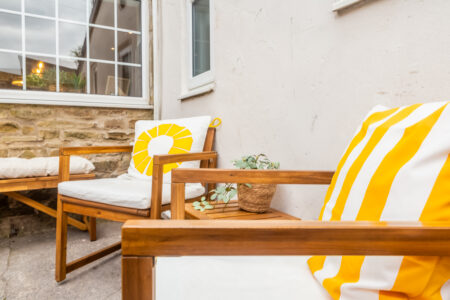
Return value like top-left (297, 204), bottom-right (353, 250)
top-left (0, 0), bottom-right (152, 109)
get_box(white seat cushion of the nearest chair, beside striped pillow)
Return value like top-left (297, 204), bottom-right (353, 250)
top-left (155, 256), bottom-right (331, 300)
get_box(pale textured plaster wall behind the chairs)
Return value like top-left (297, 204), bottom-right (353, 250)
top-left (161, 0), bottom-right (450, 219)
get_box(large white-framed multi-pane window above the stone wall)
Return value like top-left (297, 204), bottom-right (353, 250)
top-left (0, 0), bottom-right (150, 108)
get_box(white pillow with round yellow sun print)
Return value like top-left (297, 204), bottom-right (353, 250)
top-left (128, 116), bottom-right (211, 183)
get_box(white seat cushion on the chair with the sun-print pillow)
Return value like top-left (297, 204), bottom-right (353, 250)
top-left (58, 174), bottom-right (205, 209)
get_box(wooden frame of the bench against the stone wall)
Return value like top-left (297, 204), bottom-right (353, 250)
top-left (0, 173), bottom-right (95, 231)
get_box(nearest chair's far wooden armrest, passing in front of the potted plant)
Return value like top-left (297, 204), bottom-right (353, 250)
top-left (172, 169), bottom-right (334, 184)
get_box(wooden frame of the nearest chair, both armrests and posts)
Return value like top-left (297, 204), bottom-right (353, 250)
top-left (122, 169), bottom-right (450, 300)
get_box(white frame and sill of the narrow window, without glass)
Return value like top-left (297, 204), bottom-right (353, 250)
top-left (185, 0), bottom-right (215, 99)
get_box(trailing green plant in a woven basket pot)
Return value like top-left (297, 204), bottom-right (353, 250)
top-left (193, 154), bottom-right (280, 213)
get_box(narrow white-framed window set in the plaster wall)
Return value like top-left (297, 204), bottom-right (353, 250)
top-left (187, 0), bottom-right (214, 90)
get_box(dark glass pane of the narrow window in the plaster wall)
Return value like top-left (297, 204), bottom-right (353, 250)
top-left (192, 0), bottom-right (211, 77)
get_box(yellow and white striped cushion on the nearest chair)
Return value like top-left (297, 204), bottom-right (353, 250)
top-left (308, 102), bottom-right (450, 300)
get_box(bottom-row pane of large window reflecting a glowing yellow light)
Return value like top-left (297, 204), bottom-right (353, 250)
top-left (26, 56), bottom-right (56, 92)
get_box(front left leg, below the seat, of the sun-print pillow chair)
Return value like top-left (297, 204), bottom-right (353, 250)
top-left (55, 196), bottom-right (67, 282)
